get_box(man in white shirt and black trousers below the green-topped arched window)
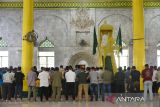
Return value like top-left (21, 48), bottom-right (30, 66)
top-left (38, 68), bottom-right (50, 101)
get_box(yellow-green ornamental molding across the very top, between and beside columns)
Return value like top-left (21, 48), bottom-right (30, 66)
top-left (0, 1), bottom-right (160, 8)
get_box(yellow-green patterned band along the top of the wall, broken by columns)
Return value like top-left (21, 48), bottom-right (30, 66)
top-left (0, 0), bottom-right (160, 8)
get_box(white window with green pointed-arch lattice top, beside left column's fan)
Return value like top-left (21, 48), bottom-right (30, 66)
top-left (38, 37), bottom-right (55, 68)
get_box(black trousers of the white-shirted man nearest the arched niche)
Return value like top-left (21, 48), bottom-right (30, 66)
top-left (66, 82), bottom-right (75, 100)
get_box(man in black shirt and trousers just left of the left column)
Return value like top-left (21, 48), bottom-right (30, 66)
top-left (14, 67), bottom-right (24, 100)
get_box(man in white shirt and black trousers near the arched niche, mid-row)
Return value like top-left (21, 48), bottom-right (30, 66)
top-left (65, 66), bottom-right (76, 100)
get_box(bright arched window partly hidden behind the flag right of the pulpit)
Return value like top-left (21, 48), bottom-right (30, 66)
top-left (114, 41), bottom-right (129, 67)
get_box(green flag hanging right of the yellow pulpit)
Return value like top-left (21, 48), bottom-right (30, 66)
top-left (116, 27), bottom-right (122, 53)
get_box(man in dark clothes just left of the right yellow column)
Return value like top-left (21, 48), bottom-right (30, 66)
top-left (130, 66), bottom-right (140, 93)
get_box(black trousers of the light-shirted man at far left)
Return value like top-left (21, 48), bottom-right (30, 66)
top-left (2, 83), bottom-right (12, 100)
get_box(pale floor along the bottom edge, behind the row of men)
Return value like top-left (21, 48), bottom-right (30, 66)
top-left (0, 101), bottom-right (160, 107)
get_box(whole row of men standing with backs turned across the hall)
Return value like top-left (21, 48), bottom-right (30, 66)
top-left (0, 64), bottom-right (160, 101)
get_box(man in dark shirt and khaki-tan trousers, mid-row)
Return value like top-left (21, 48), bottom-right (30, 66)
top-left (77, 68), bottom-right (88, 101)
